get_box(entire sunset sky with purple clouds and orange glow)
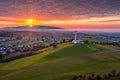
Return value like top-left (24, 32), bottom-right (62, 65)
top-left (0, 0), bottom-right (120, 31)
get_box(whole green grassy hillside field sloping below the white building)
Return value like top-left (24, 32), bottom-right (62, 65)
top-left (0, 43), bottom-right (120, 80)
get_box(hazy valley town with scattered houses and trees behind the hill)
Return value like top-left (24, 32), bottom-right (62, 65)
top-left (0, 31), bottom-right (120, 62)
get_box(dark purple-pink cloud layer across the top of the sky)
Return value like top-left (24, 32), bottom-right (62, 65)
top-left (0, 0), bottom-right (120, 20)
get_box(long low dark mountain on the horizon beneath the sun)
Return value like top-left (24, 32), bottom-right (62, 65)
top-left (3, 26), bottom-right (62, 30)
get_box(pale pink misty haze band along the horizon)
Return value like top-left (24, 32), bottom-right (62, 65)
top-left (0, 26), bottom-right (120, 33)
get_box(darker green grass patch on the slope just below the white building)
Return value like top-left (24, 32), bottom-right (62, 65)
top-left (40, 45), bottom-right (105, 61)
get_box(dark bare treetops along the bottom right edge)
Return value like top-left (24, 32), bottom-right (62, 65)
top-left (70, 69), bottom-right (120, 80)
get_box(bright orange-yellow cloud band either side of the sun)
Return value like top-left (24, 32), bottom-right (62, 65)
top-left (0, 16), bottom-right (120, 28)
